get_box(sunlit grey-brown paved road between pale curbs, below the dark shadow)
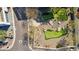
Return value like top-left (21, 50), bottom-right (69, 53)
top-left (7, 9), bottom-right (30, 51)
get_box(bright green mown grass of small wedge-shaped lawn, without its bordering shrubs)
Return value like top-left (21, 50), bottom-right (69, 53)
top-left (44, 30), bottom-right (65, 40)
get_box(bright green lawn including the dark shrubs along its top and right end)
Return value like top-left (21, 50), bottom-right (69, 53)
top-left (44, 29), bottom-right (67, 40)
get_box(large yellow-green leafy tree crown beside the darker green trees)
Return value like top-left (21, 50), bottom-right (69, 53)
top-left (53, 8), bottom-right (68, 21)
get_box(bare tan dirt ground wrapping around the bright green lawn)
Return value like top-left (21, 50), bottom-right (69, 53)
top-left (29, 19), bottom-right (74, 48)
